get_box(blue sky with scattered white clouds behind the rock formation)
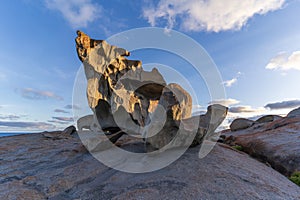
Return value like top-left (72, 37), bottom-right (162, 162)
top-left (0, 0), bottom-right (300, 132)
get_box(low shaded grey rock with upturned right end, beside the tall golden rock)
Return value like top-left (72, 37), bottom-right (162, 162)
top-left (145, 104), bottom-right (228, 149)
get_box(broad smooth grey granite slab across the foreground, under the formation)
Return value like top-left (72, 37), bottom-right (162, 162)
top-left (0, 134), bottom-right (300, 200)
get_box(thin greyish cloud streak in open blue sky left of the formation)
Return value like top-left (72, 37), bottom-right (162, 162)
top-left (16, 88), bottom-right (63, 101)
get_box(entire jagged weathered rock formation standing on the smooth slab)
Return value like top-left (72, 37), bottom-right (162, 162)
top-left (76, 31), bottom-right (227, 148)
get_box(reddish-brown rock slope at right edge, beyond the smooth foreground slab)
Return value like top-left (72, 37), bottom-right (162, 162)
top-left (223, 117), bottom-right (300, 176)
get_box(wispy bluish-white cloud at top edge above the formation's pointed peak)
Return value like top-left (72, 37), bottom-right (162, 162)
top-left (46, 0), bottom-right (102, 28)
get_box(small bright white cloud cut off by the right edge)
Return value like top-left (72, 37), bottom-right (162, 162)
top-left (266, 51), bottom-right (300, 71)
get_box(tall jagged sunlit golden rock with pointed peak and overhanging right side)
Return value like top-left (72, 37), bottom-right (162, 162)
top-left (76, 31), bottom-right (192, 142)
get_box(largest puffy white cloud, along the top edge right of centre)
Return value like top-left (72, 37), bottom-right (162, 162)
top-left (143, 0), bottom-right (285, 32)
